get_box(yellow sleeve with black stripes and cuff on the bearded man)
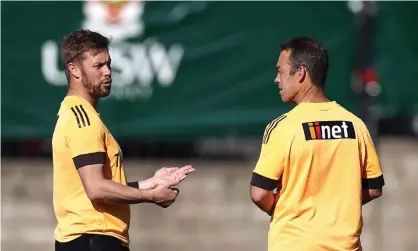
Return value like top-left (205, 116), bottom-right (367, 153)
top-left (67, 109), bottom-right (106, 169)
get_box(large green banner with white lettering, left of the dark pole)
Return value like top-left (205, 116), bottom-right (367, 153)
top-left (1, 1), bottom-right (355, 140)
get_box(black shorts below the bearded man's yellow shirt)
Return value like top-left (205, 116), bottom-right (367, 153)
top-left (55, 234), bottom-right (129, 251)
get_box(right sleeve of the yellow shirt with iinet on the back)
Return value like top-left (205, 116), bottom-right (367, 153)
top-left (362, 126), bottom-right (385, 189)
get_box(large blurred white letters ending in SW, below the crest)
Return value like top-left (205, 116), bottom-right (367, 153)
top-left (41, 39), bottom-right (184, 100)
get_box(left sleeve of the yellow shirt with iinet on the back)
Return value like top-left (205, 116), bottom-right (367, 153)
top-left (251, 121), bottom-right (286, 191)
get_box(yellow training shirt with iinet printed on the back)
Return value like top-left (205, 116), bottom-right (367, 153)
top-left (251, 102), bottom-right (384, 251)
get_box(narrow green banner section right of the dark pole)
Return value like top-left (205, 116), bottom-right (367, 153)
top-left (375, 2), bottom-right (418, 117)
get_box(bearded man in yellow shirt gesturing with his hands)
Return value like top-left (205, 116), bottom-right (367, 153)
top-left (52, 30), bottom-right (194, 251)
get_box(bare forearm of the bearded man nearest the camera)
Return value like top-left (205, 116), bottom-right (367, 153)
top-left (91, 179), bottom-right (153, 204)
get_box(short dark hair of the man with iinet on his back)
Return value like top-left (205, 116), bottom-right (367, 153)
top-left (280, 37), bottom-right (329, 88)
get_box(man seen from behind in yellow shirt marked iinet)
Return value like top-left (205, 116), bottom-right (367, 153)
top-left (250, 37), bottom-right (384, 251)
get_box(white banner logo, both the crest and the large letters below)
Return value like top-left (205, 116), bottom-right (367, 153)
top-left (41, 0), bottom-right (184, 101)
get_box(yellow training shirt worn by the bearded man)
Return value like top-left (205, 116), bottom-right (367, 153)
top-left (52, 96), bottom-right (130, 244)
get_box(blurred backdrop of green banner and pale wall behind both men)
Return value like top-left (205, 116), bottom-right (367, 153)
top-left (1, 1), bottom-right (418, 251)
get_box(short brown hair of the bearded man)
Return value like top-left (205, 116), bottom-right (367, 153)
top-left (61, 29), bottom-right (110, 79)
